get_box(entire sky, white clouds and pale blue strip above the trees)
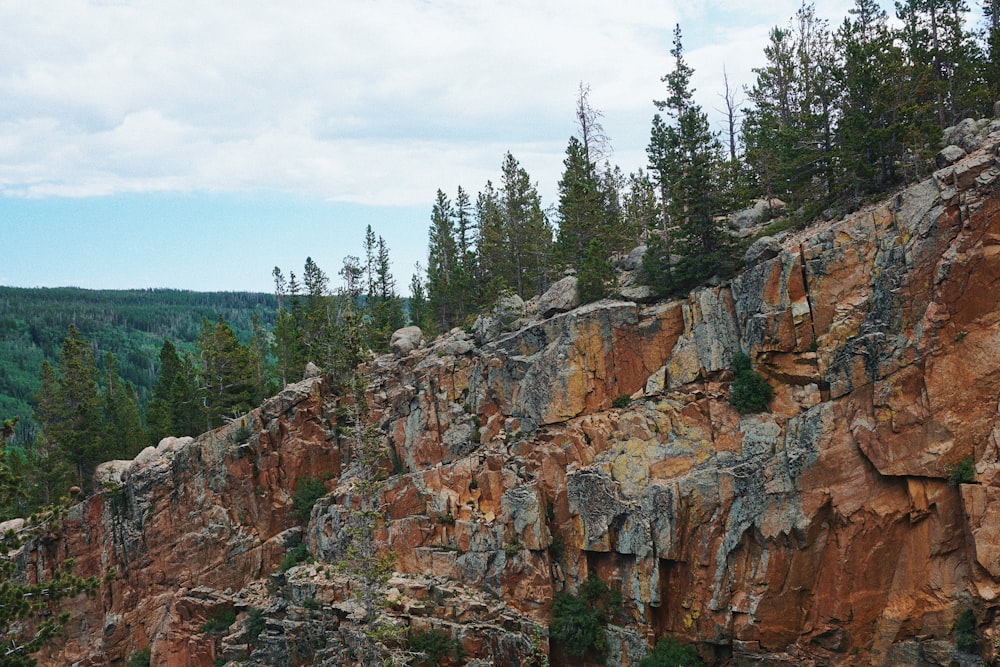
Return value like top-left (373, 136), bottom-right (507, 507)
top-left (0, 0), bottom-right (890, 293)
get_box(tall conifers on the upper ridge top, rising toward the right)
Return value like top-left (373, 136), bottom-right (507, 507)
top-left (411, 0), bottom-right (1000, 316)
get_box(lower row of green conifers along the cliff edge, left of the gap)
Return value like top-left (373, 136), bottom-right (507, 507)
top-left (0, 227), bottom-right (406, 517)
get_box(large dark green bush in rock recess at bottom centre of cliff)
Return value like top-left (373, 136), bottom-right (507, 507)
top-left (549, 573), bottom-right (622, 662)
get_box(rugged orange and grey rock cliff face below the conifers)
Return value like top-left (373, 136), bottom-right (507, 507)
top-left (17, 130), bottom-right (1000, 665)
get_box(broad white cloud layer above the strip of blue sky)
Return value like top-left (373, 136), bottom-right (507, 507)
top-left (0, 0), bottom-right (892, 204)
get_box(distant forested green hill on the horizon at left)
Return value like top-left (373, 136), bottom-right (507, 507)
top-left (0, 287), bottom-right (277, 446)
